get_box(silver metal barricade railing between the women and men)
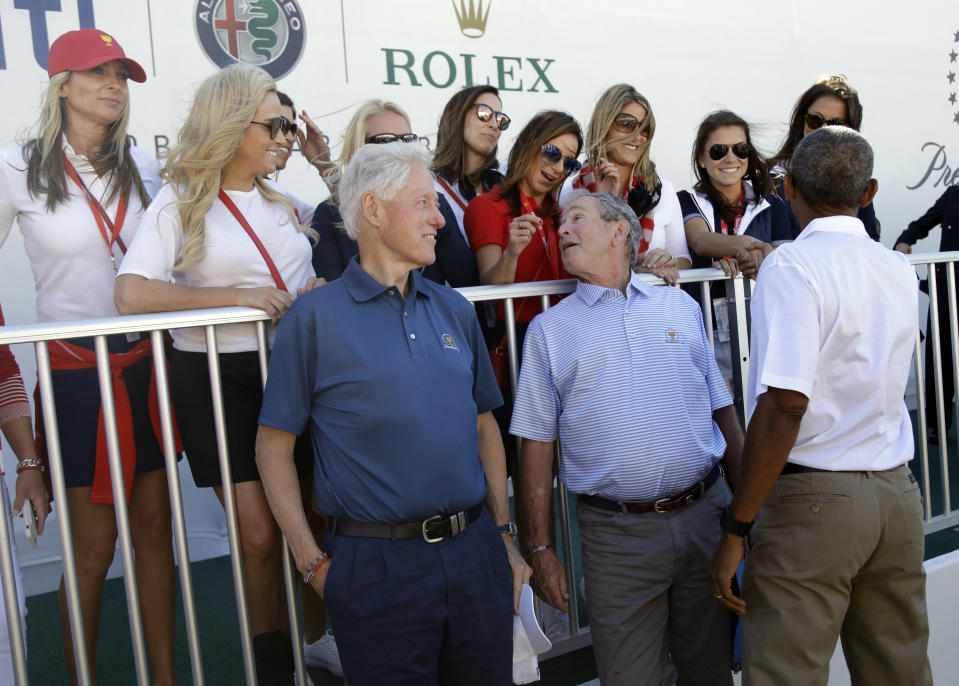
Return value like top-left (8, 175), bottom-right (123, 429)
top-left (0, 260), bottom-right (959, 686)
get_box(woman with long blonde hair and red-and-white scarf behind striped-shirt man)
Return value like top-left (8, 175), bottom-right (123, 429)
top-left (560, 83), bottom-right (692, 283)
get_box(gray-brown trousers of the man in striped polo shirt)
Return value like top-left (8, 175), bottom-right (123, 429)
top-left (577, 479), bottom-right (732, 686)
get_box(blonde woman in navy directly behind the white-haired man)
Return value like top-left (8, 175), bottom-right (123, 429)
top-left (313, 100), bottom-right (478, 288)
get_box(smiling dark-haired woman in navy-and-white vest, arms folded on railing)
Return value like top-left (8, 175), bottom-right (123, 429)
top-left (679, 110), bottom-right (792, 384)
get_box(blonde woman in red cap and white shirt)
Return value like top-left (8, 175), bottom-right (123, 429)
top-left (0, 29), bottom-right (176, 684)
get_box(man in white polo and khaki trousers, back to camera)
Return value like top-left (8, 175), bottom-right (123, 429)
top-left (710, 126), bottom-right (932, 686)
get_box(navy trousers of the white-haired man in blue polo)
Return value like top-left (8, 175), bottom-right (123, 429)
top-left (324, 508), bottom-right (513, 686)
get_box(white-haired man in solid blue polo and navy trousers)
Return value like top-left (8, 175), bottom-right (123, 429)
top-left (257, 143), bottom-right (529, 686)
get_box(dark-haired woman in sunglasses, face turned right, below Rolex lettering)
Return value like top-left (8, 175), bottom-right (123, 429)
top-left (433, 85), bottom-right (510, 238)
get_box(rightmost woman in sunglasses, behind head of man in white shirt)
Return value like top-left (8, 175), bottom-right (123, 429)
top-left (770, 74), bottom-right (881, 241)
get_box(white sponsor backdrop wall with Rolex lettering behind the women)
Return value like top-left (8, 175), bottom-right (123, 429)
top-left (0, 0), bottom-right (959, 588)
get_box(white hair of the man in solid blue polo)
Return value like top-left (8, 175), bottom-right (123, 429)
top-left (337, 141), bottom-right (432, 240)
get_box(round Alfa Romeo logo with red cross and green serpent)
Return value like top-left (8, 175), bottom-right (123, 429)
top-left (194, 0), bottom-right (305, 79)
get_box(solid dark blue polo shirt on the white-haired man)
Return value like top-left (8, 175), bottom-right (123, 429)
top-left (260, 259), bottom-right (503, 524)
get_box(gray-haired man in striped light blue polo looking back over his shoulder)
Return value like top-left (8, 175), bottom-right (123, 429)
top-left (511, 193), bottom-right (742, 685)
